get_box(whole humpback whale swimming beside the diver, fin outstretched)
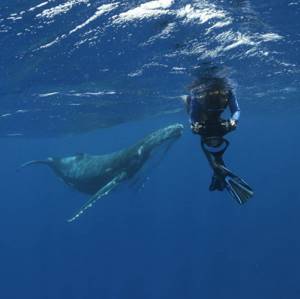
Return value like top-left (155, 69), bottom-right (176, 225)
top-left (21, 124), bottom-right (183, 222)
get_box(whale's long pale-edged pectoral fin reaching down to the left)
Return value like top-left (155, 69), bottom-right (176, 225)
top-left (68, 172), bottom-right (126, 222)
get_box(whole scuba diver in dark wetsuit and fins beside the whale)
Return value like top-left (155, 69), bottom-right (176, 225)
top-left (184, 77), bottom-right (254, 204)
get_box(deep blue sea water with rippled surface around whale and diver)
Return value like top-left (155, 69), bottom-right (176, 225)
top-left (0, 0), bottom-right (300, 299)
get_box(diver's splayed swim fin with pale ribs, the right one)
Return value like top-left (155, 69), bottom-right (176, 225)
top-left (218, 165), bottom-right (254, 205)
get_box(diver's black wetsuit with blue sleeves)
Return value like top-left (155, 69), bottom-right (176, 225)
top-left (187, 90), bottom-right (240, 191)
